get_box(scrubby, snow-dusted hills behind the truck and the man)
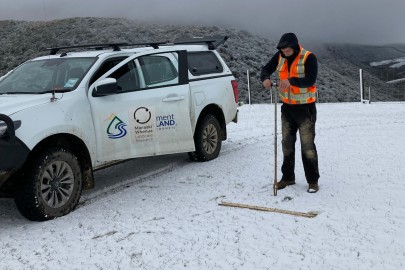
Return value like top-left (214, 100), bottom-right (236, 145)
top-left (0, 18), bottom-right (405, 103)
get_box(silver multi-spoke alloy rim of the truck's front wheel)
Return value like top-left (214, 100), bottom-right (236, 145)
top-left (41, 161), bottom-right (74, 208)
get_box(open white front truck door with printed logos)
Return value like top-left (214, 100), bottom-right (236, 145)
top-left (89, 51), bottom-right (194, 162)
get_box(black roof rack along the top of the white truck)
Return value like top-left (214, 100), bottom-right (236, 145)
top-left (46, 36), bottom-right (228, 55)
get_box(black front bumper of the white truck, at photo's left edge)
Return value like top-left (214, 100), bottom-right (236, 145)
top-left (0, 114), bottom-right (30, 189)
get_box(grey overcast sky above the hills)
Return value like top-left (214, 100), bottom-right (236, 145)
top-left (0, 0), bottom-right (405, 44)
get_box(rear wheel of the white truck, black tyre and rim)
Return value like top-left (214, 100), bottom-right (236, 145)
top-left (189, 114), bottom-right (222, 161)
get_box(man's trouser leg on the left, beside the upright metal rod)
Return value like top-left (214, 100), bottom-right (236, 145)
top-left (281, 105), bottom-right (298, 182)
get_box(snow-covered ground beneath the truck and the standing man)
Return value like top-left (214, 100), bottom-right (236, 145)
top-left (0, 103), bottom-right (405, 270)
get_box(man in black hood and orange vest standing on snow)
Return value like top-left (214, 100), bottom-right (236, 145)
top-left (260, 33), bottom-right (319, 193)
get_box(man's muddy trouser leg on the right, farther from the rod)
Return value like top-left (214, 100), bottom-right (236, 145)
top-left (299, 106), bottom-right (319, 184)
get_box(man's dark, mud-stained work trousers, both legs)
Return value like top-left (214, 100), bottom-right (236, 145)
top-left (281, 103), bottom-right (319, 184)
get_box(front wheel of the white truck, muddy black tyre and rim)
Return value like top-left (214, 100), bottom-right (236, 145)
top-left (15, 147), bottom-right (82, 221)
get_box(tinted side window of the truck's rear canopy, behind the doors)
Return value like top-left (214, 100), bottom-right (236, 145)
top-left (188, 52), bottom-right (224, 75)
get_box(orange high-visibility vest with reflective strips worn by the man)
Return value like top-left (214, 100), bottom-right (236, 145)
top-left (277, 46), bottom-right (316, 104)
